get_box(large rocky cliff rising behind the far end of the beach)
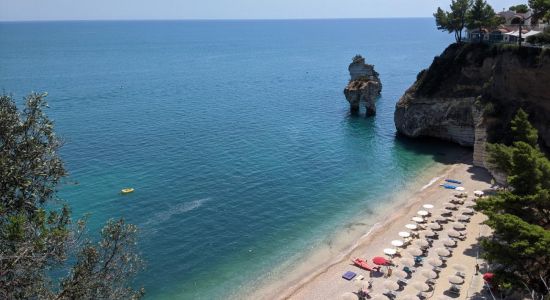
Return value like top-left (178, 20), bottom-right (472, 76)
top-left (395, 44), bottom-right (550, 172)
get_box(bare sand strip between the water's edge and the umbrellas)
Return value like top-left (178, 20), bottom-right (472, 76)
top-left (244, 157), bottom-right (490, 299)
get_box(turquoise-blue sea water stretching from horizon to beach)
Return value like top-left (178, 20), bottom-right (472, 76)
top-left (0, 19), bottom-right (462, 299)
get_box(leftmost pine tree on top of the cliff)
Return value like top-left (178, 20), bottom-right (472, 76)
top-left (434, 0), bottom-right (472, 43)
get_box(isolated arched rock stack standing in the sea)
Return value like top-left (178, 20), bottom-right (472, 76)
top-left (344, 55), bottom-right (382, 116)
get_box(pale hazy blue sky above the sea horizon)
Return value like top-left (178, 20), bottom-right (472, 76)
top-left (0, 0), bottom-right (527, 21)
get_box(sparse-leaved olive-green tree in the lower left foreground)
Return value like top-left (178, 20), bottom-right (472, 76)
top-left (0, 93), bottom-right (143, 299)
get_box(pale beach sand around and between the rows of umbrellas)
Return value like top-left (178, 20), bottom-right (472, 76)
top-left (249, 163), bottom-right (490, 299)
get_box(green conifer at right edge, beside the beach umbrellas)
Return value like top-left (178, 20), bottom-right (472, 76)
top-left (476, 110), bottom-right (550, 299)
